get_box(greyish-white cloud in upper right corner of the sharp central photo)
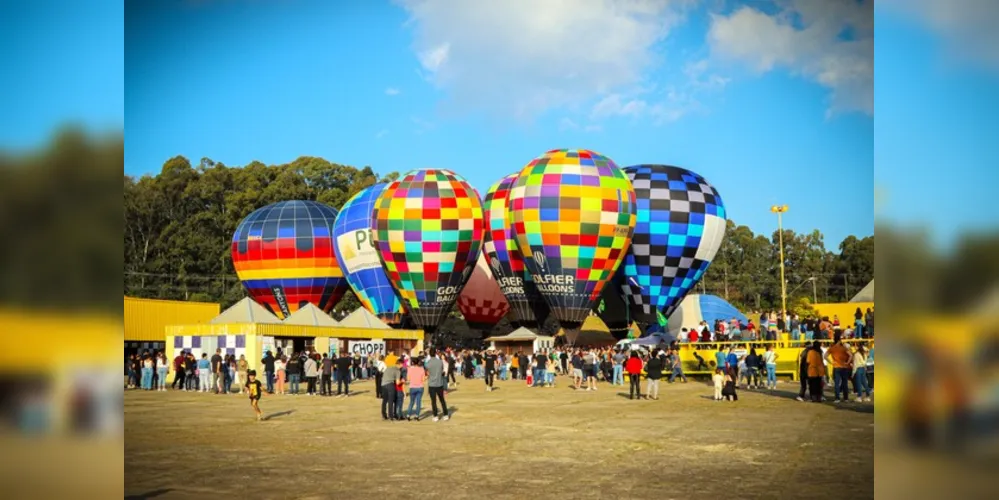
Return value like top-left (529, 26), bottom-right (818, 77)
top-left (708, 0), bottom-right (874, 114)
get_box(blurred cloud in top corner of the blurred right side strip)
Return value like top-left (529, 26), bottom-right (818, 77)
top-left (880, 0), bottom-right (999, 70)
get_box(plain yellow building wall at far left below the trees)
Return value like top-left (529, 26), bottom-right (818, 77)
top-left (124, 297), bottom-right (220, 342)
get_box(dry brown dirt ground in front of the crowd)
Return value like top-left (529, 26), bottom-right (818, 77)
top-left (125, 380), bottom-right (874, 500)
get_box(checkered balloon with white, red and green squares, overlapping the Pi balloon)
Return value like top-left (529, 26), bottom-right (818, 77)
top-left (372, 170), bottom-right (485, 333)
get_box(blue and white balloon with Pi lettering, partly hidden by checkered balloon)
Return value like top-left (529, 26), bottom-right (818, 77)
top-left (333, 184), bottom-right (403, 325)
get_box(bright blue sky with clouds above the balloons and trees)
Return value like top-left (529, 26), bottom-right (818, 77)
top-left (41, 0), bottom-right (999, 247)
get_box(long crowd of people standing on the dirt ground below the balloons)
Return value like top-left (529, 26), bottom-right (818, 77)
top-left (126, 330), bottom-right (872, 422)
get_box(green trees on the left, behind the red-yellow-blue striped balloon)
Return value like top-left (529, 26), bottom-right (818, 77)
top-left (124, 156), bottom-right (398, 300)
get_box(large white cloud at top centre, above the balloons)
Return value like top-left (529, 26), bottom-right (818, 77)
top-left (397, 0), bottom-right (691, 121)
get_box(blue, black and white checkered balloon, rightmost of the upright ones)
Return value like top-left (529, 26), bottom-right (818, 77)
top-left (615, 165), bottom-right (726, 325)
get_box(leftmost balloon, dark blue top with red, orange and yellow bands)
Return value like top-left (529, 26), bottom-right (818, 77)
top-left (232, 201), bottom-right (347, 319)
